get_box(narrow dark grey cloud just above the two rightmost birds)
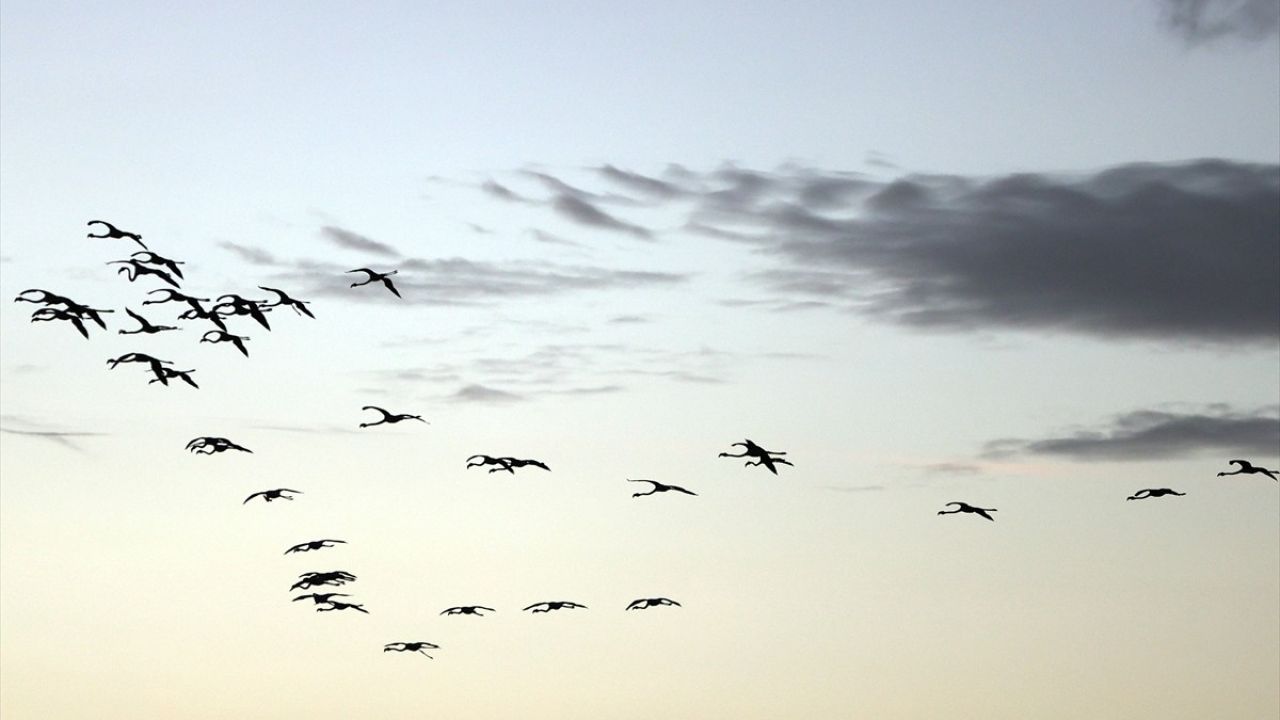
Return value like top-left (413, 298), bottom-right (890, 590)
top-left (983, 406), bottom-right (1280, 461)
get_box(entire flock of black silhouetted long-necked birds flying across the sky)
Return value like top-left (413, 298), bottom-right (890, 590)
top-left (14, 220), bottom-right (1280, 657)
